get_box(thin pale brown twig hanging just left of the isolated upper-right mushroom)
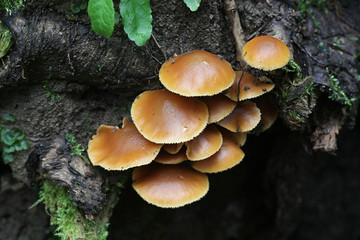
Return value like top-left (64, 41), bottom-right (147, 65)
top-left (223, 0), bottom-right (246, 67)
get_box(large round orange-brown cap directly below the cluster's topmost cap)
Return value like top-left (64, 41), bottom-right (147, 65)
top-left (131, 89), bottom-right (209, 143)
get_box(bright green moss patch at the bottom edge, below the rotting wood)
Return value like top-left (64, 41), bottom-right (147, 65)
top-left (32, 180), bottom-right (109, 240)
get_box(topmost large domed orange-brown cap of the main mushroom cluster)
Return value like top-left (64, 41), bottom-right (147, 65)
top-left (159, 50), bottom-right (235, 97)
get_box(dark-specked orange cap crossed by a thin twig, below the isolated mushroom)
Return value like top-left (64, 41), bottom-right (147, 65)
top-left (225, 71), bottom-right (275, 101)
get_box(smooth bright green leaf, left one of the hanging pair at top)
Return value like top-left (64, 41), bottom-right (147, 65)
top-left (88, 0), bottom-right (115, 38)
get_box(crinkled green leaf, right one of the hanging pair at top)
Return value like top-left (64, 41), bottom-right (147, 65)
top-left (120, 0), bottom-right (152, 46)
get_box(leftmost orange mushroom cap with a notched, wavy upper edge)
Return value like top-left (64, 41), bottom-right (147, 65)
top-left (87, 118), bottom-right (162, 170)
